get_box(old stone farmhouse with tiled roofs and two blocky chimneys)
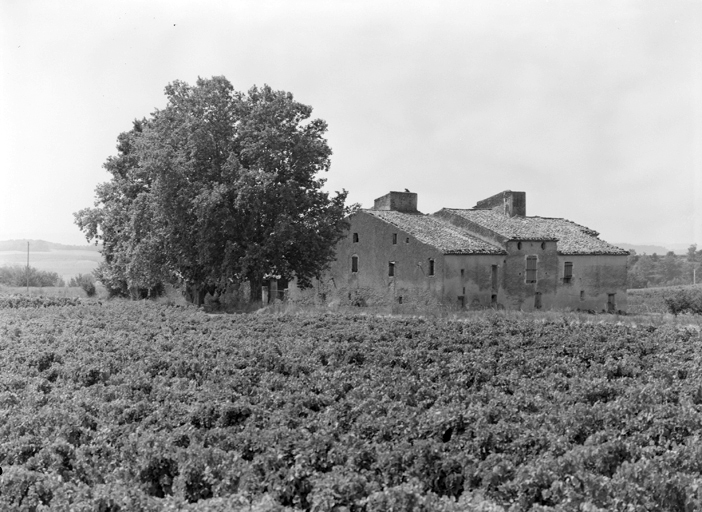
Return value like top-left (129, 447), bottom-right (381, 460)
top-left (290, 190), bottom-right (628, 312)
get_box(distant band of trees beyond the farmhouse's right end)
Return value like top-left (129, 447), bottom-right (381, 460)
top-left (628, 245), bottom-right (702, 288)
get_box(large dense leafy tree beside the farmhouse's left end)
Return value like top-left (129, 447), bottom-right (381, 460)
top-left (75, 77), bottom-right (350, 302)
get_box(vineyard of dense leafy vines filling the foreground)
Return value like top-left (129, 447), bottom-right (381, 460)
top-left (0, 298), bottom-right (702, 512)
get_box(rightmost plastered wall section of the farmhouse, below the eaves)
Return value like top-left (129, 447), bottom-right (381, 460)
top-left (558, 255), bottom-right (627, 313)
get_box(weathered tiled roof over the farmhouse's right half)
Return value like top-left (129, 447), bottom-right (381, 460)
top-left (445, 208), bottom-right (628, 255)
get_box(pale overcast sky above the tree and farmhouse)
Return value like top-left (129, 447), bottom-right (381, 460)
top-left (0, 0), bottom-right (702, 246)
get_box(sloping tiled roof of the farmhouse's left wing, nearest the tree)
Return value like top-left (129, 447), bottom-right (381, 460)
top-left (362, 210), bottom-right (505, 254)
